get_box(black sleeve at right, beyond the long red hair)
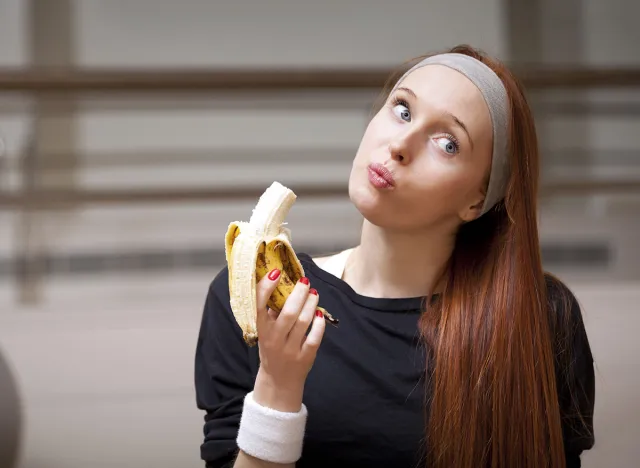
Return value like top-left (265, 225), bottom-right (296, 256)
top-left (549, 280), bottom-right (595, 468)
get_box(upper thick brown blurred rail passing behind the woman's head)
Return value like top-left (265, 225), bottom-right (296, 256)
top-left (0, 67), bottom-right (640, 93)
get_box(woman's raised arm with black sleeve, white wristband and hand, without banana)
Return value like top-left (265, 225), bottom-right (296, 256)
top-left (195, 268), bottom-right (324, 468)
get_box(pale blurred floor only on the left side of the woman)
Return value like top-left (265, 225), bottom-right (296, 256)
top-left (0, 274), bottom-right (209, 468)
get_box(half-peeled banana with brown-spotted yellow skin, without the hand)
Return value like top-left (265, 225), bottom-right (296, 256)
top-left (225, 182), bottom-right (338, 346)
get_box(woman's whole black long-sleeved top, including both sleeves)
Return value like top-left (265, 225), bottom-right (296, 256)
top-left (195, 254), bottom-right (594, 468)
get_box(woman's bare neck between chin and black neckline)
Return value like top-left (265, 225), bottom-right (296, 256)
top-left (344, 220), bottom-right (455, 298)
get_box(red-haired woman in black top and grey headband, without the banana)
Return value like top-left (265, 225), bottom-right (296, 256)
top-left (196, 46), bottom-right (594, 468)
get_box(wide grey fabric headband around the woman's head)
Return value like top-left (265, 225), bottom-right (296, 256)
top-left (392, 53), bottom-right (509, 214)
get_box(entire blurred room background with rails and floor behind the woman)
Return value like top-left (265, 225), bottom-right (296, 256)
top-left (0, 0), bottom-right (640, 468)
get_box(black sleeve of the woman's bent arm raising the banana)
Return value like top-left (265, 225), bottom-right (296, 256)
top-left (194, 267), bottom-right (257, 468)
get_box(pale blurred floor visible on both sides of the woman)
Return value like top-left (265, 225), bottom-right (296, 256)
top-left (0, 272), bottom-right (640, 468)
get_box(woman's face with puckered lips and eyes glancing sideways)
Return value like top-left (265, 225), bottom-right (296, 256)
top-left (349, 65), bottom-right (493, 230)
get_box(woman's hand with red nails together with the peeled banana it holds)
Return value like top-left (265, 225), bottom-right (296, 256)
top-left (225, 182), bottom-right (338, 412)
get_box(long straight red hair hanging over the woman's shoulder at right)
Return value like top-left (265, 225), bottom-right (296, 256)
top-left (378, 46), bottom-right (565, 468)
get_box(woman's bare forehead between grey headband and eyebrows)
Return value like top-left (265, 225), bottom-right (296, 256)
top-left (399, 65), bottom-right (491, 130)
